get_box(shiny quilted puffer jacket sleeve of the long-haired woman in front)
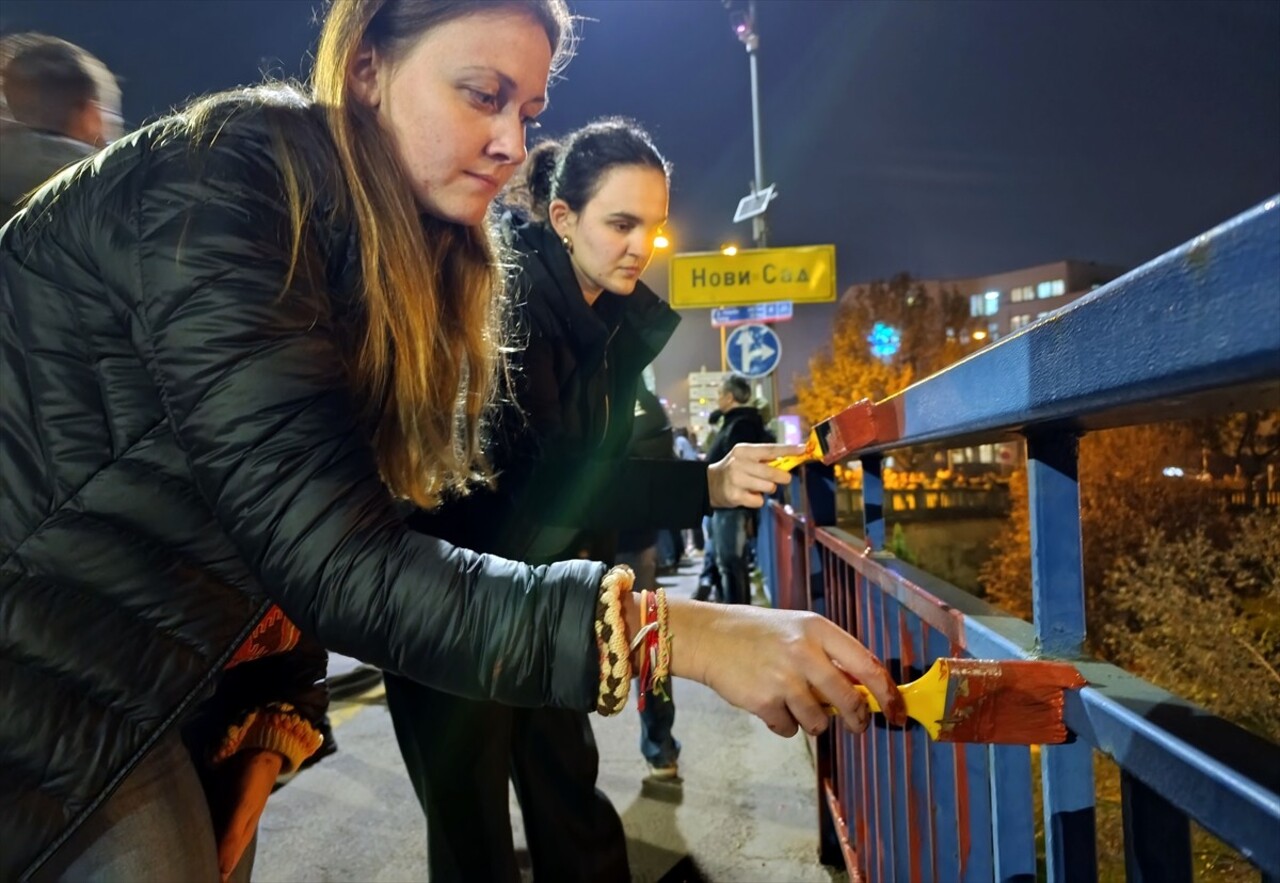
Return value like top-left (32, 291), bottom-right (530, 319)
top-left (116, 129), bottom-right (604, 709)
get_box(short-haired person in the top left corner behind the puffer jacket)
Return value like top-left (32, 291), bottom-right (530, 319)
top-left (0, 33), bottom-right (122, 224)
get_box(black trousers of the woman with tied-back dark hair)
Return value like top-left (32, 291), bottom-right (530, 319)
top-left (385, 674), bottom-right (631, 883)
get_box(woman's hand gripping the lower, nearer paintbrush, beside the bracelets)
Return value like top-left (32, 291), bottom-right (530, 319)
top-left (668, 599), bottom-right (906, 736)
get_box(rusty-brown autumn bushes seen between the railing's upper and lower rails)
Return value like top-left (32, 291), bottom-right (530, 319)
top-left (980, 424), bottom-right (1280, 738)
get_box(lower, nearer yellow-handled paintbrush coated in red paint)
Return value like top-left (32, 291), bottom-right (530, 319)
top-left (826, 659), bottom-right (1085, 745)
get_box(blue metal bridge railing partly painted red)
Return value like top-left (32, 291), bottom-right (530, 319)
top-left (760, 198), bottom-right (1280, 883)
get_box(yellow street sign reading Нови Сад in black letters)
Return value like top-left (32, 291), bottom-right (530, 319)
top-left (671, 246), bottom-right (836, 310)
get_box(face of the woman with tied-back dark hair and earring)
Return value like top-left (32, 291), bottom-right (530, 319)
top-left (549, 165), bottom-right (667, 301)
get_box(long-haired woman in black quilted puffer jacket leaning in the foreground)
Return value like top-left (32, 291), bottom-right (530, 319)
top-left (0, 0), bottom-right (896, 879)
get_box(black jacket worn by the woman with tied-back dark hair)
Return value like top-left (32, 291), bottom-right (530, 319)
top-left (413, 223), bottom-right (710, 562)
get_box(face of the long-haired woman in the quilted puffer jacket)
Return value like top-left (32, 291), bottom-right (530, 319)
top-left (351, 8), bottom-right (552, 225)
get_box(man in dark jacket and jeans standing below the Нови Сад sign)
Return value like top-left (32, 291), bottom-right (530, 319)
top-left (707, 374), bottom-right (773, 604)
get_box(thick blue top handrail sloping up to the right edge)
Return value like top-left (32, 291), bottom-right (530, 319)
top-left (844, 195), bottom-right (1280, 454)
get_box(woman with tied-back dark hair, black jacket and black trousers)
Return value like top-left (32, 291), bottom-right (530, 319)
top-left (388, 119), bottom-right (786, 880)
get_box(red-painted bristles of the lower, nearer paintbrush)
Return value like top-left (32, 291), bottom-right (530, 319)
top-left (937, 659), bottom-right (1085, 745)
